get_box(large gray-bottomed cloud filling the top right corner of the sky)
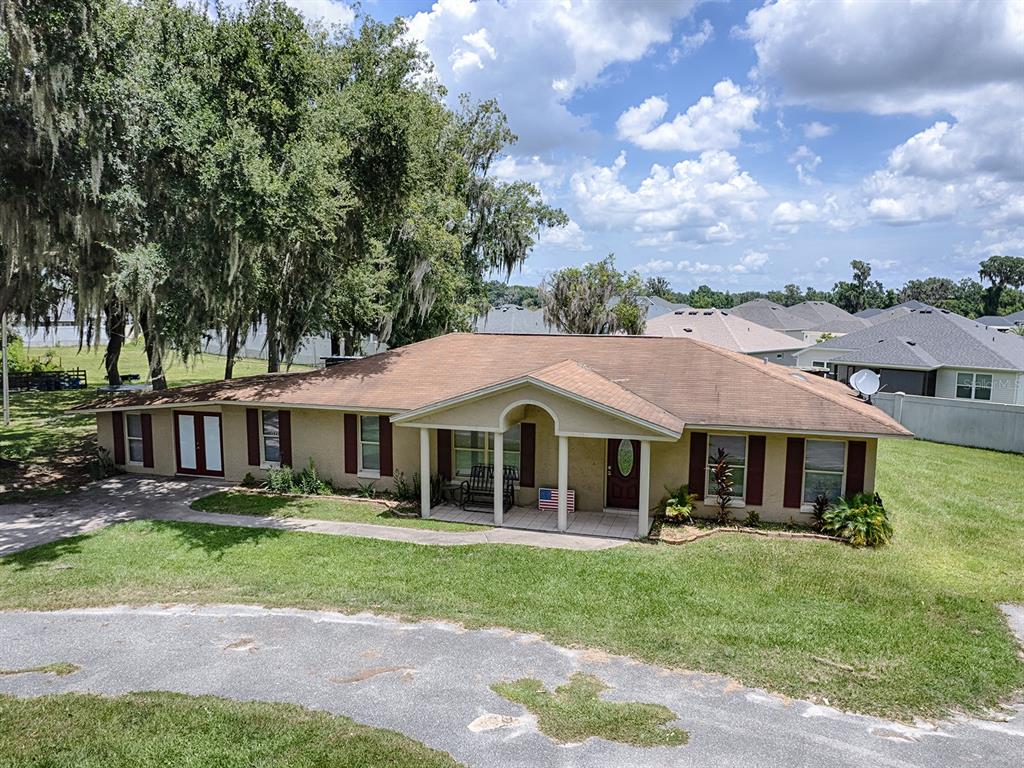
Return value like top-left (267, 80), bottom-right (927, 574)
top-left (742, 0), bottom-right (1024, 114)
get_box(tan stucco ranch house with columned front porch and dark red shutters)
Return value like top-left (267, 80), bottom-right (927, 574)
top-left (79, 334), bottom-right (910, 536)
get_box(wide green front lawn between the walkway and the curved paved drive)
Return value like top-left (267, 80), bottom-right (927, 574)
top-left (0, 441), bottom-right (1024, 717)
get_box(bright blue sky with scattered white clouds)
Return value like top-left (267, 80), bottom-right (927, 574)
top-left (288, 0), bottom-right (1024, 290)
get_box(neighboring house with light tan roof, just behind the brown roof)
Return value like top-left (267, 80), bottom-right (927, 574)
top-left (644, 307), bottom-right (807, 366)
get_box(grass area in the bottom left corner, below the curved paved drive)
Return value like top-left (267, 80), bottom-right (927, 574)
top-left (0, 693), bottom-right (459, 768)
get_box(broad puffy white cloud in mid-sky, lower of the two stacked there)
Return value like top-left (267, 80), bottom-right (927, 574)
top-left (570, 151), bottom-right (766, 246)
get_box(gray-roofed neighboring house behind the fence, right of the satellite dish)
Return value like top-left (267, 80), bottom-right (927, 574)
top-left (797, 308), bottom-right (1024, 404)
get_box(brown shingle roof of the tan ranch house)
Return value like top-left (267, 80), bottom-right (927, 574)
top-left (83, 334), bottom-right (910, 435)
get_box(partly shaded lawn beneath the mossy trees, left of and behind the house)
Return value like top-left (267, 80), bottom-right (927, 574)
top-left (0, 343), bottom-right (303, 503)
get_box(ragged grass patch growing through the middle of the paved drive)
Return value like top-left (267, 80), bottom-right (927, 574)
top-left (490, 672), bottom-right (689, 746)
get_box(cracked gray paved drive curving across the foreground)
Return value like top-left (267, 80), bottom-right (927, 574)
top-left (0, 606), bottom-right (1024, 768)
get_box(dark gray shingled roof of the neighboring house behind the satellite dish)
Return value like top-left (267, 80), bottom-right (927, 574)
top-left (810, 309), bottom-right (1024, 371)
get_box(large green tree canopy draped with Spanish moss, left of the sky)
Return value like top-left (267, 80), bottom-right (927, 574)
top-left (0, 0), bottom-right (567, 386)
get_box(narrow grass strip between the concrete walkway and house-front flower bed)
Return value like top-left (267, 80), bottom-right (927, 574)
top-left (193, 490), bottom-right (484, 530)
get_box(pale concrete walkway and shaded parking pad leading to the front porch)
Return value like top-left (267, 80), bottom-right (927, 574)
top-left (0, 475), bottom-right (627, 556)
